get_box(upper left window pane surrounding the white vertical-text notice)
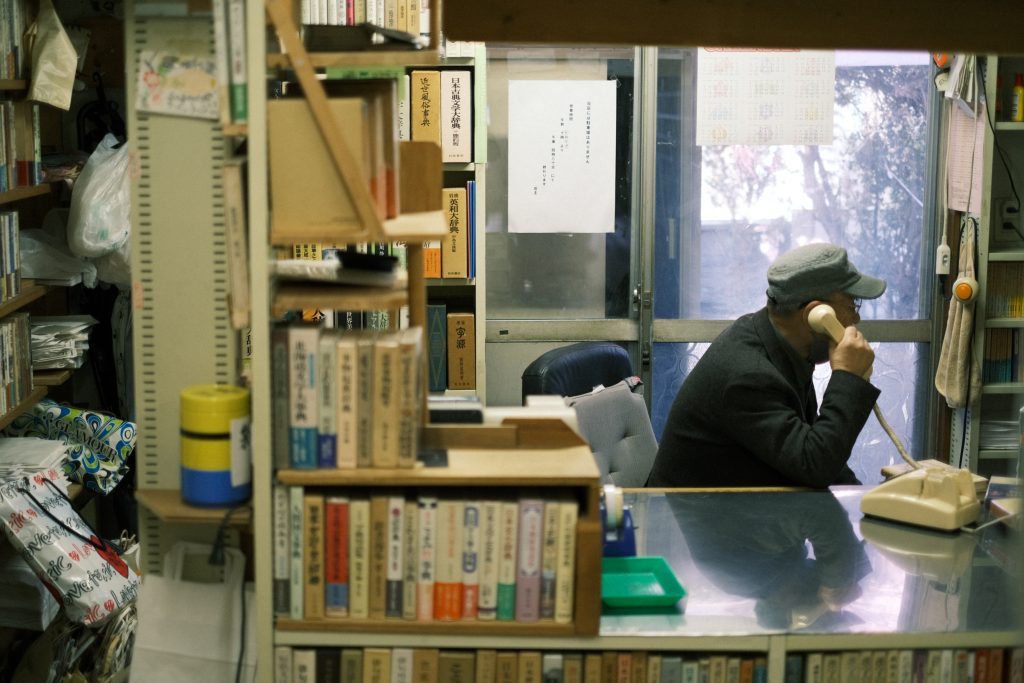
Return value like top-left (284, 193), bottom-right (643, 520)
top-left (485, 47), bottom-right (634, 319)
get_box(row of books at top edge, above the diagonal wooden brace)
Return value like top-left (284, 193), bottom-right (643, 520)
top-left (299, 0), bottom-right (430, 34)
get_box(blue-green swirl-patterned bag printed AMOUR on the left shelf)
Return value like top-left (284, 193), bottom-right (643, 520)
top-left (4, 398), bottom-right (137, 494)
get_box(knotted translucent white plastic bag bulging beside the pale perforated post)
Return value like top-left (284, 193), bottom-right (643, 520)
top-left (68, 133), bottom-right (131, 258)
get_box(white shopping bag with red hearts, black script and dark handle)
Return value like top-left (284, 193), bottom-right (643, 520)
top-left (0, 470), bottom-right (138, 626)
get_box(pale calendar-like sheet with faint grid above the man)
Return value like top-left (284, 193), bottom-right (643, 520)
top-left (696, 47), bottom-right (836, 144)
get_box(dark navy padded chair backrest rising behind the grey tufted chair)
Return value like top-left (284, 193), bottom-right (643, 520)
top-left (522, 342), bottom-right (634, 405)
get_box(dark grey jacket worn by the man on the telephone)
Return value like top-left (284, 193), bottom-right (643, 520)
top-left (647, 308), bottom-right (879, 488)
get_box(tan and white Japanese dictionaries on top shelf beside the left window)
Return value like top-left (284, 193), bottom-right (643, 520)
top-left (398, 69), bottom-right (474, 164)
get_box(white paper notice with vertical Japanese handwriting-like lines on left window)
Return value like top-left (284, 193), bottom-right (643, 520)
top-left (509, 81), bottom-right (615, 232)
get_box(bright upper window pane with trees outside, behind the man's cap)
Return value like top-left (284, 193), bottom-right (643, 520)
top-left (654, 50), bottom-right (934, 319)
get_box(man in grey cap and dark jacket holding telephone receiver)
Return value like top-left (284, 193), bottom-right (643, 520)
top-left (647, 244), bottom-right (886, 487)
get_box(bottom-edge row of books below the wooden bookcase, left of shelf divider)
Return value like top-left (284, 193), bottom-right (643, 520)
top-left (273, 646), bottom-right (768, 683)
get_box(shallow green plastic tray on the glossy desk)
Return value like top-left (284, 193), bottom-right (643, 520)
top-left (601, 556), bottom-right (686, 607)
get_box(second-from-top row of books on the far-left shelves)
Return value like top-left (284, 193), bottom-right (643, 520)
top-left (0, 98), bottom-right (43, 193)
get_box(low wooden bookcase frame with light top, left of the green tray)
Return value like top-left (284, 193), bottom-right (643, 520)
top-left (276, 419), bottom-right (602, 637)
